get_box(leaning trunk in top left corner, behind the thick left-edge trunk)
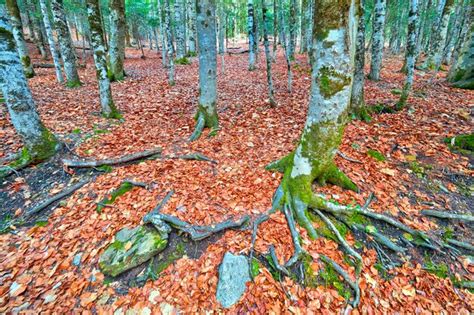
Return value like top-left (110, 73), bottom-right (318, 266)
top-left (5, 0), bottom-right (35, 78)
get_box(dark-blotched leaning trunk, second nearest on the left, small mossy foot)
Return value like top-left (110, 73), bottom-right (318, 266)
top-left (86, 0), bottom-right (122, 119)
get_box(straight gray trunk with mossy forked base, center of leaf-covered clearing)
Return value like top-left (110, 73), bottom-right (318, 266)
top-left (190, 0), bottom-right (219, 141)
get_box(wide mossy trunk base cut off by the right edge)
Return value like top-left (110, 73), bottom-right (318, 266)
top-left (448, 23), bottom-right (474, 90)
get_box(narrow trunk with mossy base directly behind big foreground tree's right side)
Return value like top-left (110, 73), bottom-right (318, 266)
top-left (351, 1), bottom-right (370, 122)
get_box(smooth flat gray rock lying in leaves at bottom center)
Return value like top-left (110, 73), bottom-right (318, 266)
top-left (216, 252), bottom-right (250, 308)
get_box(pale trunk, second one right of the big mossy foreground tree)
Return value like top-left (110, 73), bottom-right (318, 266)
top-left (369, 0), bottom-right (387, 81)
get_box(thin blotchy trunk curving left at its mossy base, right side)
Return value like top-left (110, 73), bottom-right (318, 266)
top-left (396, 0), bottom-right (418, 110)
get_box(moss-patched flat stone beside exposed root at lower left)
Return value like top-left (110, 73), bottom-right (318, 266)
top-left (99, 226), bottom-right (168, 277)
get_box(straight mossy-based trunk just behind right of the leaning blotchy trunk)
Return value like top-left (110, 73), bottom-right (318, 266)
top-left (109, 0), bottom-right (127, 81)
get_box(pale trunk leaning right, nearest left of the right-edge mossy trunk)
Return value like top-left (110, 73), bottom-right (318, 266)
top-left (423, 0), bottom-right (454, 71)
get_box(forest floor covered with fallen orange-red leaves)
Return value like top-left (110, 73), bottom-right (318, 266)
top-left (0, 43), bottom-right (474, 314)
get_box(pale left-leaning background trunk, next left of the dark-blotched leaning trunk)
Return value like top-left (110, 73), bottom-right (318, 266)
top-left (51, 0), bottom-right (81, 88)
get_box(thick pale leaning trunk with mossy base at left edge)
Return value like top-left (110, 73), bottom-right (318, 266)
top-left (0, 16), bottom-right (58, 163)
